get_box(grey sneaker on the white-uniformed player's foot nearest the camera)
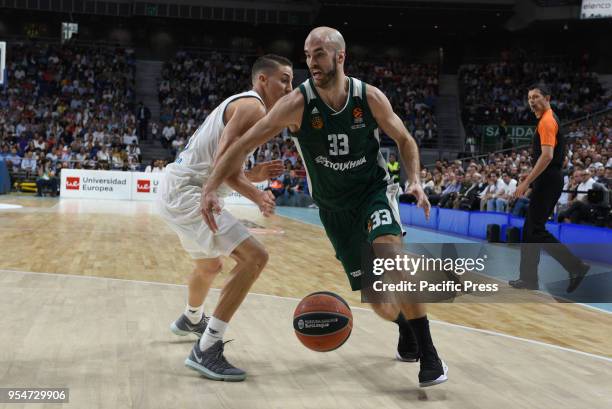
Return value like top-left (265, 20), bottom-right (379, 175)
top-left (185, 340), bottom-right (246, 382)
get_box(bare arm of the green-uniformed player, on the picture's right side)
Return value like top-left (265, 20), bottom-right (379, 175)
top-left (366, 85), bottom-right (431, 219)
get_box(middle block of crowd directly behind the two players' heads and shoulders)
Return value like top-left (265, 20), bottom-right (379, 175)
top-left (157, 51), bottom-right (438, 163)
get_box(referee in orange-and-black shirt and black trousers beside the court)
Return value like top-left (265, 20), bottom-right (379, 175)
top-left (509, 85), bottom-right (590, 293)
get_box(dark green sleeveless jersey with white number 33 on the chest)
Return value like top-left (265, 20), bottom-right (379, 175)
top-left (293, 77), bottom-right (391, 211)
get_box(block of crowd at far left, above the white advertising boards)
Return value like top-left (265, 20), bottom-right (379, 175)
top-left (0, 42), bottom-right (141, 194)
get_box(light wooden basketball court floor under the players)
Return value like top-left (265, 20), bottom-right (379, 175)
top-left (0, 196), bottom-right (612, 409)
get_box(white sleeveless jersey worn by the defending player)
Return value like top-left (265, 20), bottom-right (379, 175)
top-left (166, 90), bottom-right (263, 186)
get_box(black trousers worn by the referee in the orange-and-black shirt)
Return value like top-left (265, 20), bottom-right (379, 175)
top-left (520, 167), bottom-right (582, 284)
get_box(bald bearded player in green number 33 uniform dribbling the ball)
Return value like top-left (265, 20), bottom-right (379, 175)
top-left (201, 27), bottom-right (447, 386)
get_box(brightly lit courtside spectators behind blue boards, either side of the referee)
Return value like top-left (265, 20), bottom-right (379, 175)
top-left (403, 114), bottom-right (612, 226)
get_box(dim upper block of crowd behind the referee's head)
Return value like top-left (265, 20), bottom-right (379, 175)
top-left (459, 52), bottom-right (612, 142)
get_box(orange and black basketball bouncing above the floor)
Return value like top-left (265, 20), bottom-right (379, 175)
top-left (293, 291), bottom-right (353, 352)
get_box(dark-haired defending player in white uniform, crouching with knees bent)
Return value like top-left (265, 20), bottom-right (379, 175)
top-left (158, 55), bottom-right (293, 381)
